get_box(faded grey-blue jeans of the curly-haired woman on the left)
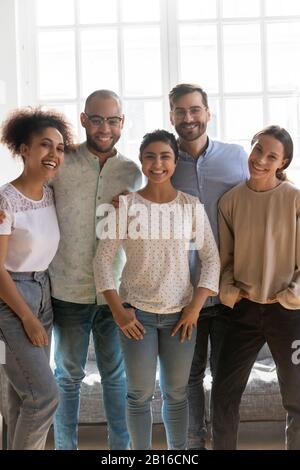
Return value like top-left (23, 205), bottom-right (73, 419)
top-left (0, 272), bottom-right (58, 450)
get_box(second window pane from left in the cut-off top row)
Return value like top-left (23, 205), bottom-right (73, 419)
top-left (79, 0), bottom-right (117, 24)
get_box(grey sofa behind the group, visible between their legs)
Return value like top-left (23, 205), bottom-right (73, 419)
top-left (0, 341), bottom-right (285, 446)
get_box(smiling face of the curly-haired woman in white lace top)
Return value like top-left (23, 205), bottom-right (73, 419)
top-left (20, 127), bottom-right (64, 181)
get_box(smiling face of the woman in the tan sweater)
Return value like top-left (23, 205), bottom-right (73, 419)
top-left (248, 135), bottom-right (287, 183)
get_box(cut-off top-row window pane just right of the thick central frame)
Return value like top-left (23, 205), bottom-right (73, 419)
top-left (177, 0), bottom-right (217, 20)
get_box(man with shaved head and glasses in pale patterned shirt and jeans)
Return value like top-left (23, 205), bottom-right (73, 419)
top-left (50, 90), bottom-right (142, 450)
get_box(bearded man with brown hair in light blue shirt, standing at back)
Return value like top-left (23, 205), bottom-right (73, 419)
top-left (169, 83), bottom-right (248, 449)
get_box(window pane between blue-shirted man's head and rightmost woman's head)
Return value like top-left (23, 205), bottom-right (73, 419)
top-left (225, 98), bottom-right (263, 141)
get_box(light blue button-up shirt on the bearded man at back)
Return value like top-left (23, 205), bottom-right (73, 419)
top-left (172, 139), bottom-right (249, 307)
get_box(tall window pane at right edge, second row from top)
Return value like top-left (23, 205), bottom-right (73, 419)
top-left (267, 23), bottom-right (300, 91)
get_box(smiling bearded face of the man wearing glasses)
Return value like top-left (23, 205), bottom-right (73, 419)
top-left (80, 96), bottom-right (124, 156)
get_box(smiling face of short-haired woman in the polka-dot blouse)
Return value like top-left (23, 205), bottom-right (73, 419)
top-left (141, 141), bottom-right (176, 184)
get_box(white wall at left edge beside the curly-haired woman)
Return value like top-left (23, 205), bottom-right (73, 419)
top-left (0, 0), bottom-right (21, 185)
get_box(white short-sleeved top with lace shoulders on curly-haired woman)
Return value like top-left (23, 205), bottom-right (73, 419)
top-left (0, 184), bottom-right (59, 272)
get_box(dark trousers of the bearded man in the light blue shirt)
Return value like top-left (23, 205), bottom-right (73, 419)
top-left (188, 304), bottom-right (231, 449)
